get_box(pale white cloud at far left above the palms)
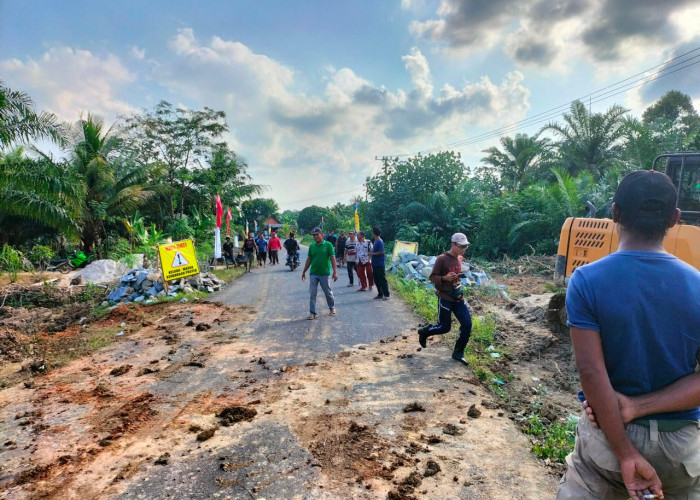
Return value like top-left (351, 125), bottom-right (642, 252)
top-left (0, 46), bottom-right (135, 122)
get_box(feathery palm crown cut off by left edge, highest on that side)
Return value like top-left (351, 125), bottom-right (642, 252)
top-left (0, 80), bottom-right (64, 148)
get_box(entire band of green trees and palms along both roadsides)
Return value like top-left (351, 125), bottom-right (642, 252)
top-left (0, 81), bottom-right (700, 266)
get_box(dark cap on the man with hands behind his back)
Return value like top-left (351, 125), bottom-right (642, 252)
top-left (613, 170), bottom-right (678, 221)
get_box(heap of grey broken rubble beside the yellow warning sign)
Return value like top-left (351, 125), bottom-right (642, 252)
top-left (106, 268), bottom-right (225, 304)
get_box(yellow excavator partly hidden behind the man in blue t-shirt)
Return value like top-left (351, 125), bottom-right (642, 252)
top-left (547, 151), bottom-right (700, 333)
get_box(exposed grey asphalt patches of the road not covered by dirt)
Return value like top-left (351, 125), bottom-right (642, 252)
top-left (118, 247), bottom-right (424, 500)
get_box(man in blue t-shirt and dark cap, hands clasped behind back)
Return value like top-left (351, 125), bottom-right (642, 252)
top-left (557, 171), bottom-right (700, 500)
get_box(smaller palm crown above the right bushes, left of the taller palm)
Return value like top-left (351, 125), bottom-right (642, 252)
top-left (481, 134), bottom-right (550, 191)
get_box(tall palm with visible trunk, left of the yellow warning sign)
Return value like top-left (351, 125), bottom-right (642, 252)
top-left (72, 115), bottom-right (154, 253)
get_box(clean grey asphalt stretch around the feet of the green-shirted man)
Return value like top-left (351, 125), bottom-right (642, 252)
top-left (211, 247), bottom-right (419, 364)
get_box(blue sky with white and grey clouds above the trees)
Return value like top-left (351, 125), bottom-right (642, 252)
top-left (0, 0), bottom-right (700, 210)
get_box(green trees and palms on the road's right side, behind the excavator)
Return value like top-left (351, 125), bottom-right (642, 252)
top-left (299, 91), bottom-right (700, 260)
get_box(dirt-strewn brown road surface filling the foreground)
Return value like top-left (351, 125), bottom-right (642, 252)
top-left (0, 258), bottom-right (578, 499)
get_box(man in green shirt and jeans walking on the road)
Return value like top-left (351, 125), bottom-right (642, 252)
top-left (301, 227), bottom-right (338, 319)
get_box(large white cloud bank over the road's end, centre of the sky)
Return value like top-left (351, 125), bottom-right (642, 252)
top-left (152, 29), bottom-right (529, 207)
